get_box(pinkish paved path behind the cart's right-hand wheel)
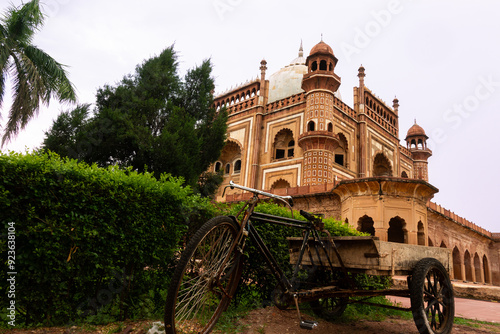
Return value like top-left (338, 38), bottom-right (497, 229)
top-left (387, 296), bottom-right (500, 323)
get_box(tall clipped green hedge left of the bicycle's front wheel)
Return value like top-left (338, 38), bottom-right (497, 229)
top-left (0, 153), bottom-right (215, 325)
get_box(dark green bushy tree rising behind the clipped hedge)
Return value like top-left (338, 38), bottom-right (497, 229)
top-left (43, 47), bottom-right (227, 190)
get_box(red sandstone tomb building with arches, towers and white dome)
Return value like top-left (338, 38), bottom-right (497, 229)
top-left (213, 41), bottom-right (500, 285)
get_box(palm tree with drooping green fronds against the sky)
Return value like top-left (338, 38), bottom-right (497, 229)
top-left (0, 0), bottom-right (76, 146)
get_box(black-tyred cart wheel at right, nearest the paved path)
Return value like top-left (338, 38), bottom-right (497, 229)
top-left (410, 258), bottom-right (455, 334)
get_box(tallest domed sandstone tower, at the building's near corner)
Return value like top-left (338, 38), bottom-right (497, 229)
top-left (298, 41), bottom-right (340, 185)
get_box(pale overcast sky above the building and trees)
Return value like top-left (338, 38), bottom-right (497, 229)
top-left (0, 0), bottom-right (500, 232)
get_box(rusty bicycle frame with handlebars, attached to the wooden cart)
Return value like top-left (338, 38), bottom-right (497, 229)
top-left (227, 181), bottom-right (410, 329)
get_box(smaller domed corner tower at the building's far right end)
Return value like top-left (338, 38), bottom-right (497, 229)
top-left (405, 120), bottom-right (432, 182)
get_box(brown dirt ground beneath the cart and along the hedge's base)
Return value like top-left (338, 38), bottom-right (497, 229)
top-left (0, 307), bottom-right (500, 334)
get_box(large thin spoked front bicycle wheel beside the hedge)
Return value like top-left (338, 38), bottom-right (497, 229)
top-left (165, 216), bottom-right (241, 334)
